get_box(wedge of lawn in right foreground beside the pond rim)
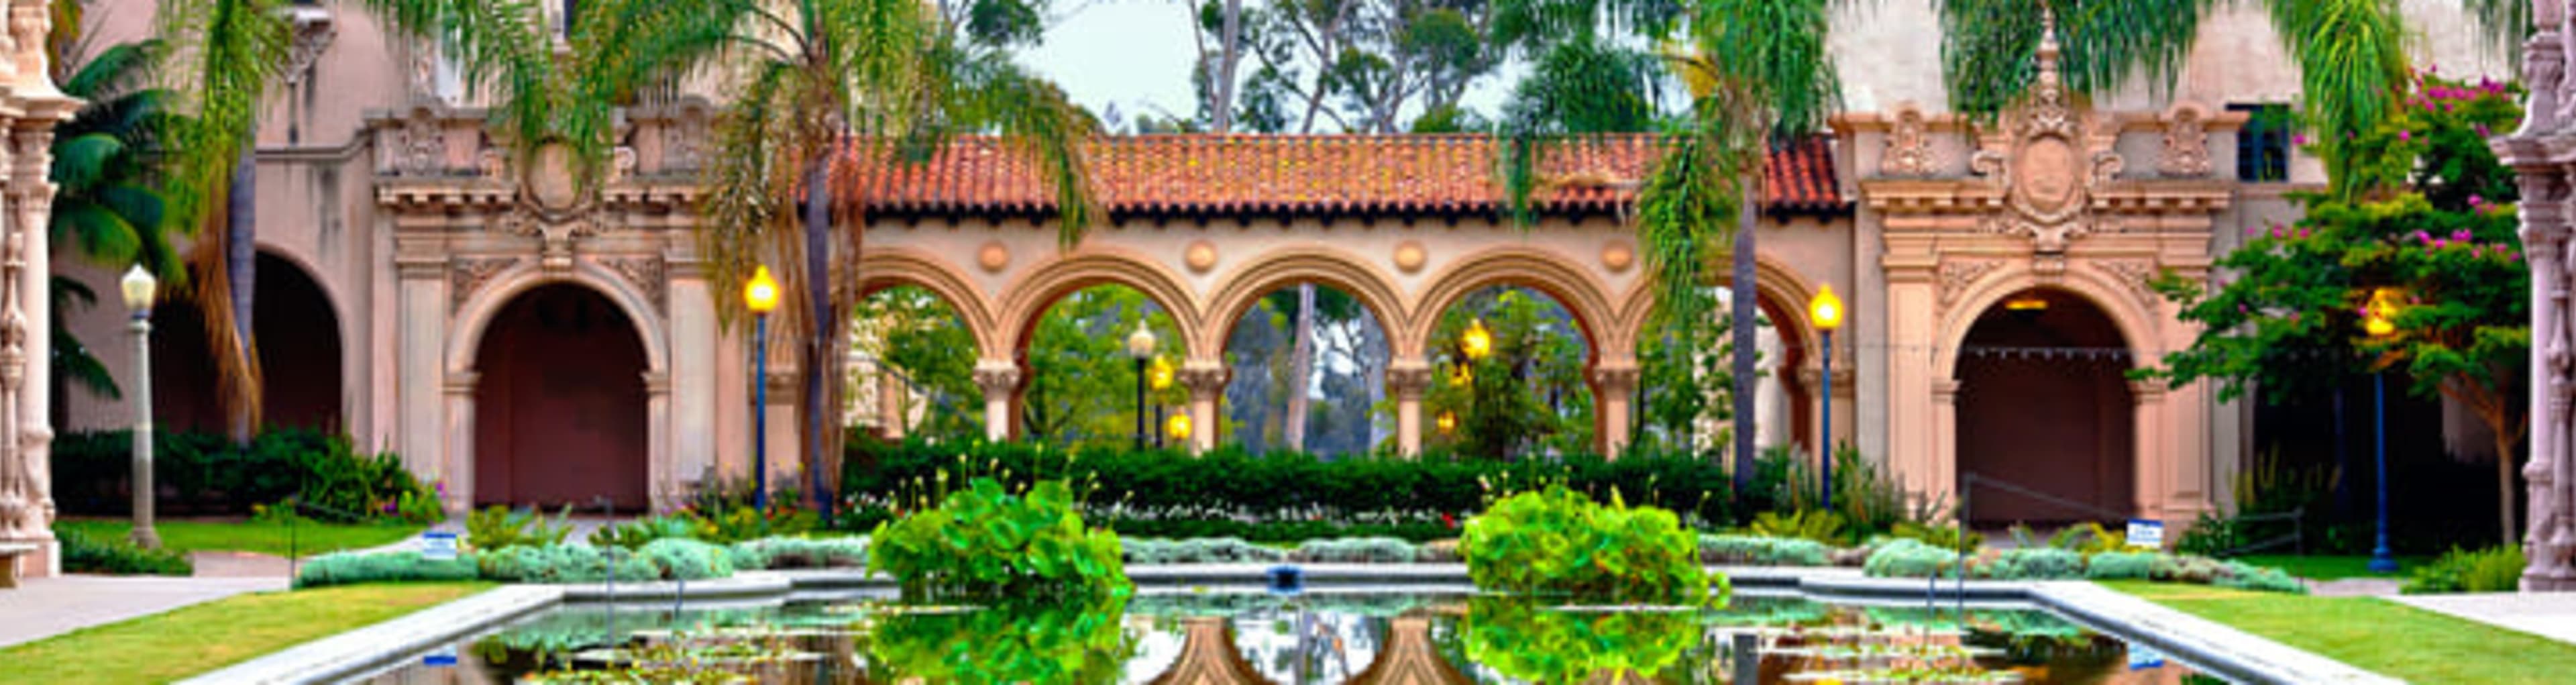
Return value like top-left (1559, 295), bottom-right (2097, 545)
top-left (2102, 582), bottom-right (2576, 682)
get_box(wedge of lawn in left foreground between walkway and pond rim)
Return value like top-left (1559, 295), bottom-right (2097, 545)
top-left (0, 582), bottom-right (492, 682)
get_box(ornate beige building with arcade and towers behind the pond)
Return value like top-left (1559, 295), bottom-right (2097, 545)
top-left (15, 0), bottom-right (2499, 576)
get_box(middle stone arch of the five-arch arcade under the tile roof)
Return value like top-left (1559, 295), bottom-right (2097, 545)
top-left (1193, 245), bottom-right (1422, 358)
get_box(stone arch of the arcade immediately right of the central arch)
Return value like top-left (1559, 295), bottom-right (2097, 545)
top-left (1391, 247), bottom-right (1633, 363)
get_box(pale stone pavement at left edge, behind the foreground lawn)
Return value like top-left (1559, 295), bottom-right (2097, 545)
top-left (0, 574), bottom-right (286, 646)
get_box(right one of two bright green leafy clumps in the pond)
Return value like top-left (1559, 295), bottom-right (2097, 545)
top-left (1458, 486), bottom-right (1726, 602)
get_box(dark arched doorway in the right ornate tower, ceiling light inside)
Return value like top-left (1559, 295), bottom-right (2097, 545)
top-left (1957, 288), bottom-right (2138, 525)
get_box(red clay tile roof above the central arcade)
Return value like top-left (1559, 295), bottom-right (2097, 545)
top-left (835, 134), bottom-right (1849, 216)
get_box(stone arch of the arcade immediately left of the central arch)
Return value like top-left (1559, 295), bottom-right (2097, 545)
top-left (1000, 250), bottom-right (1208, 358)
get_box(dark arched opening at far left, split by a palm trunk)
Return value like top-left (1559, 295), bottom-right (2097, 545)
top-left (145, 250), bottom-right (345, 433)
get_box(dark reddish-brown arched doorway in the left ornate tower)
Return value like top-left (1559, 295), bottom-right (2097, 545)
top-left (474, 283), bottom-right (649, 510)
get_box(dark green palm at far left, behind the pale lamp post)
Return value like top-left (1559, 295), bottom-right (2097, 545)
top-left (49, 41), bottom-right (183, 399)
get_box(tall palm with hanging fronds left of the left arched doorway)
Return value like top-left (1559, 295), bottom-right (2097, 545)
top-left (160, 0), bottom-right (294, 443)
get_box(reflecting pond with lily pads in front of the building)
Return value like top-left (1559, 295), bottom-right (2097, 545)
top-left (363, 592), bottom-right (2220, 685)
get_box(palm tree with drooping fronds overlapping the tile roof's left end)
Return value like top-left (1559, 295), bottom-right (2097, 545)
top-left (577, 0), bottom-right (1097, 513)
